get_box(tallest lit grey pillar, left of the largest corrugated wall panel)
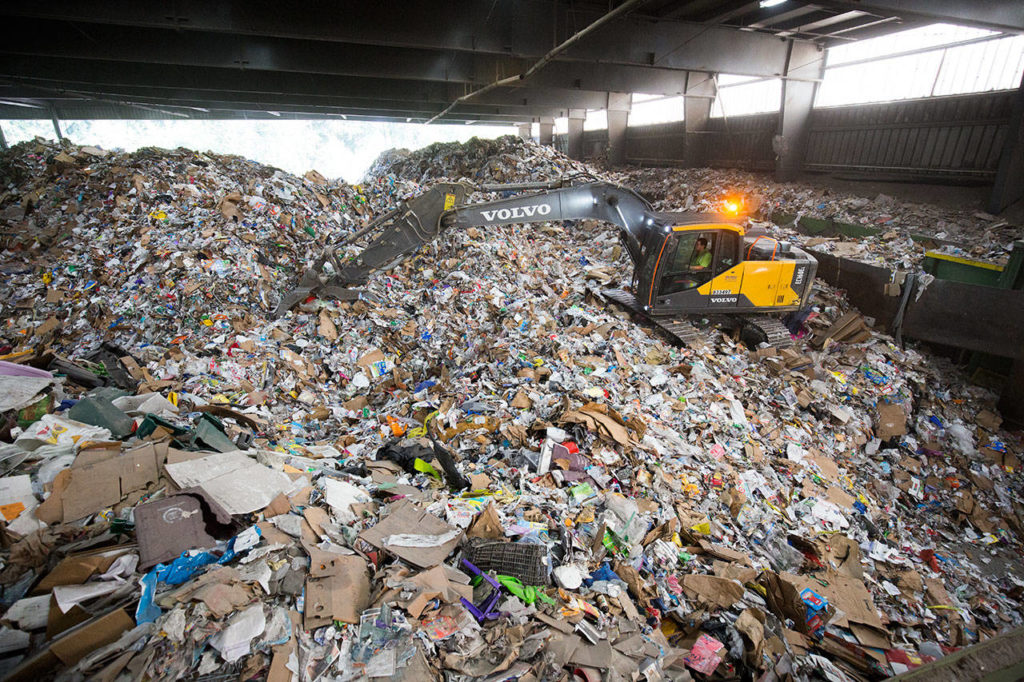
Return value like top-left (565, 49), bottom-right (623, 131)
top-left (772, 40), bottom-right (825, 181)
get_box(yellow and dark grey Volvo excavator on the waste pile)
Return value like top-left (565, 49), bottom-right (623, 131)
top-left (275, 176), bottom-right (817, 348)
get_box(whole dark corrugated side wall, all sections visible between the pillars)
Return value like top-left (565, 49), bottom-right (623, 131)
top-left (573, 90), bottom-right (1014, 179)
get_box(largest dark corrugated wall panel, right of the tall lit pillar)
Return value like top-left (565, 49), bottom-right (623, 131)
top-left (804, 91), bottom-right (1014, 178)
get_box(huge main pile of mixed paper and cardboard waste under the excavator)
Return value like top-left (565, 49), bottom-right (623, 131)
top-left (0, 138), bottom-right (1024, 682)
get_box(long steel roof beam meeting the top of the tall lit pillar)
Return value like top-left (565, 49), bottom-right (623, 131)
top-left (2, 12), bottom-right (815, 84)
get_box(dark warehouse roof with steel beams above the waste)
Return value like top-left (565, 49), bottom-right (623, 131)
top-left (0, 0), bottom-right (1024, 123)
